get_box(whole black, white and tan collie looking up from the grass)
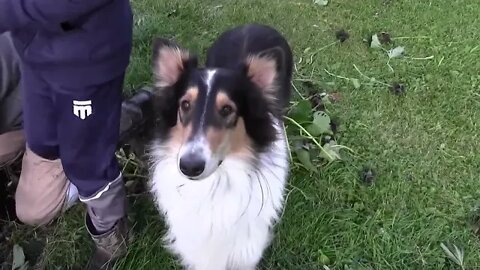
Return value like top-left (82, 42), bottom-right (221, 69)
top-left (149, 24), bottom-right (293, 270)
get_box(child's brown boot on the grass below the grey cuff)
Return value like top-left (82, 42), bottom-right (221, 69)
top-left (85, 214), bottom-right (129, 270)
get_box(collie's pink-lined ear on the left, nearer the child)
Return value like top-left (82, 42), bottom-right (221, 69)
top-left (152, 38), bottom-right (198, 89)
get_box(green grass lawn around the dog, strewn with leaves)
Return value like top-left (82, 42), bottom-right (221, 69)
top-left (3, 0), bottom-right (480, 270)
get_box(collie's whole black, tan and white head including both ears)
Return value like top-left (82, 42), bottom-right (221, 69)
top-left (153, 39), bottom-right (282, 180)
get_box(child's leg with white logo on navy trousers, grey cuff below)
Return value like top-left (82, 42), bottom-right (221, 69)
top-left (55, 76), bottom-right (127, 268)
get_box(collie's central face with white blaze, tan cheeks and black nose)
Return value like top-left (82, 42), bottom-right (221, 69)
top-left (178, 74), bottom-right (239, 179)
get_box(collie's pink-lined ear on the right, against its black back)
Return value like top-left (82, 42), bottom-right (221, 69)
top-left (245, 47), bottom-right (285, 100)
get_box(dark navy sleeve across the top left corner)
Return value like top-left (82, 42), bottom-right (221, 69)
top-left (0, 0), bottom-right (115, 33)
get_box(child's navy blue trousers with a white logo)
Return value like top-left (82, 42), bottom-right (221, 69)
top-left (21, 67), bottom-right (124, 198)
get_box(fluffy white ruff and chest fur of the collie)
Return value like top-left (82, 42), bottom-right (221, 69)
top-left (150, 124), bottom-right (289, 270)
